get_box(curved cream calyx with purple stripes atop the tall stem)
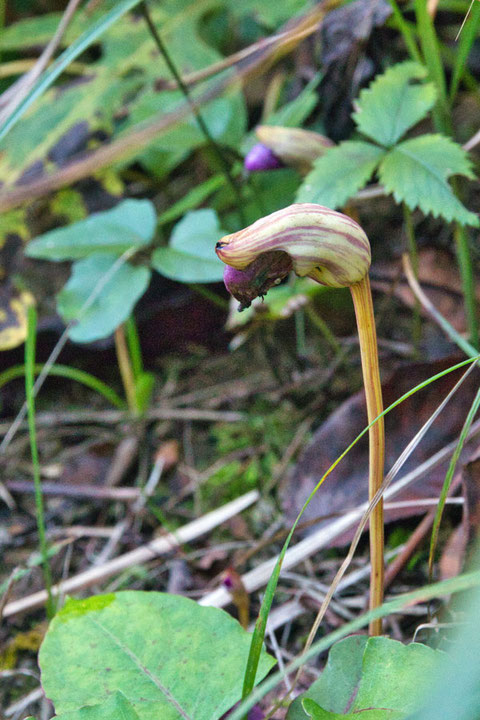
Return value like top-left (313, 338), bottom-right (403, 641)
top-left (215, 203), bottom-right (371, 294)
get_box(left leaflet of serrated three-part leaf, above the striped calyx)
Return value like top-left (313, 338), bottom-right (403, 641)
top-left (297, 140), bottom-right (385, 208)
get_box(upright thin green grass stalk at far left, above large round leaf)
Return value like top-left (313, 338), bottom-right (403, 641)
top-left (25, 305), bottom-right (55, 619)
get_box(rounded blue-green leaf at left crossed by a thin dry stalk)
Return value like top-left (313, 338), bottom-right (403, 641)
top-left (57, 253), bottom-right (150, 342)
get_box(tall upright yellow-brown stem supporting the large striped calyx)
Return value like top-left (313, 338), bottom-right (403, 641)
top-left (350, 275), bottom-right (385, 635)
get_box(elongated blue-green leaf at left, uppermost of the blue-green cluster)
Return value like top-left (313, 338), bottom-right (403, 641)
top-left (25, 200), bottom-right (156, 260)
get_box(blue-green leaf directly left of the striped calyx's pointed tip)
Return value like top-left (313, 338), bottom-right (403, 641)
top-left (152, 210), bottom-right (225, 283)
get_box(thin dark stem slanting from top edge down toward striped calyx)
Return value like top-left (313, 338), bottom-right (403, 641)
top-left (140, 0), bottom-right (247, 225)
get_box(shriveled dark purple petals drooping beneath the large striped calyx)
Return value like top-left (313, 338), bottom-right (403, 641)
top-left (223, 251), bottom-right (293, 310)
